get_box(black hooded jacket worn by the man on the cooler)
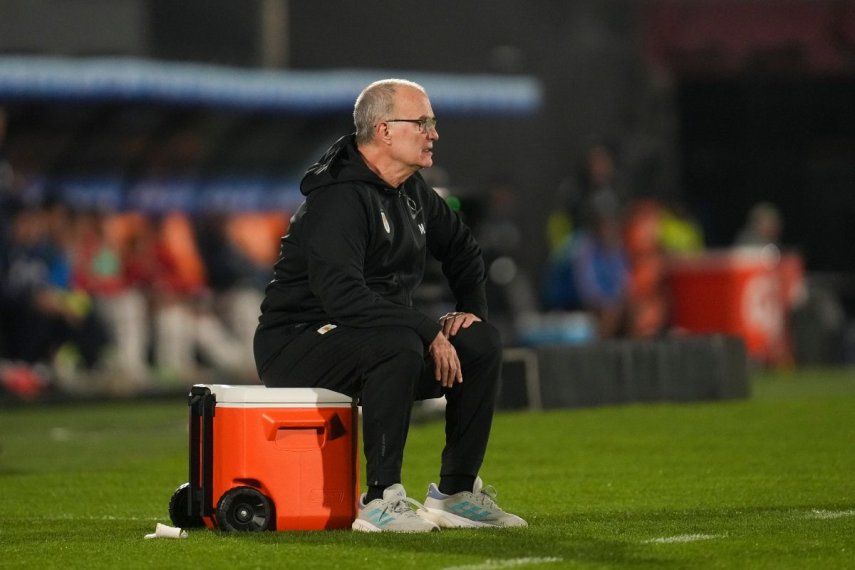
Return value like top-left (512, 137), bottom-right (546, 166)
top-left (256, 135), bottom-right (487, 368)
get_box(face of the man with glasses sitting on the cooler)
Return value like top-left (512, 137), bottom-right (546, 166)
top-left (387, 87), bottom-right (439, 172)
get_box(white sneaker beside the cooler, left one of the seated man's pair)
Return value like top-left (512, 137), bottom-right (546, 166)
top-left (351, 483), bottom-right (439, 532)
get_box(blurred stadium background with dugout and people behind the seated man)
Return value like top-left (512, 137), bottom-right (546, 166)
top-left (0, 0), bottom-right (855, 401)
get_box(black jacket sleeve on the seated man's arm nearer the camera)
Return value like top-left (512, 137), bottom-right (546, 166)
top-left (303, 186), bottom-right (441, 344)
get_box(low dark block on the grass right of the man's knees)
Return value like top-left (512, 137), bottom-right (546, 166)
top-left (499, 335), bottom-right (749, 409)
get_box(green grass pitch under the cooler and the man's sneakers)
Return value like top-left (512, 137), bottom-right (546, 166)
top-left (0, 371), bottom-right (855, 570)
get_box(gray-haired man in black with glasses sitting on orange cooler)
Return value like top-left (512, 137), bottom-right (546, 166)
top-left (255, 79), bottom-right (526, 532)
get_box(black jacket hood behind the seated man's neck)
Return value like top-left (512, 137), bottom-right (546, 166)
top-left (300, 134), bottom-right (388, 196)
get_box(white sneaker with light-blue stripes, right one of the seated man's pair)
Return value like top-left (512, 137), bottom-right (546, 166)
top-left (424, 477), bottom-right (528, 528)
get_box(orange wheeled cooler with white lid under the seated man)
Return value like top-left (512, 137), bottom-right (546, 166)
top-left (170, 384), bottom-right (359, 531)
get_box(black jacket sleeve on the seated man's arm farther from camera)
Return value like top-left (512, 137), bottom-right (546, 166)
top-left (425, 184), bottom-right (487, 321)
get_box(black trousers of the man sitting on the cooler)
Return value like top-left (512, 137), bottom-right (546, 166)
top-left (256, 322), bottom-right (502, 486)
